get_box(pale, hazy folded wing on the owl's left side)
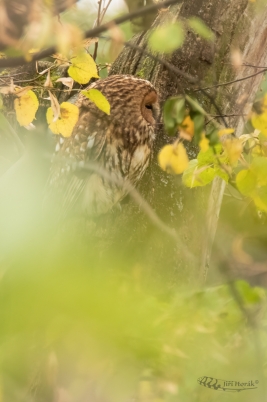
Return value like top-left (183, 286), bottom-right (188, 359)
top-left (47, 107), bottom-right (106, 218)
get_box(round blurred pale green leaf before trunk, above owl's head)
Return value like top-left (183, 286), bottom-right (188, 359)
top-left (148, 22), bottom-right (184, 53)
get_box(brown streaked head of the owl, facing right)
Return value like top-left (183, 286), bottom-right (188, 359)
top-left (80, 75), bottom-right (159, 127)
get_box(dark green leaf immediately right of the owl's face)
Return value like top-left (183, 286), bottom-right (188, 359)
top-left (163, 96), bottom-right (185, 135)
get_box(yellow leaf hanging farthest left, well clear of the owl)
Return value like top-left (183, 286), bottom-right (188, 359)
top-left (14, 91), bottom-right (39, 126)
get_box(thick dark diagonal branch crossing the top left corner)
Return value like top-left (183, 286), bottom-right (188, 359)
top-left (0, 0), bottom-right (182, 68)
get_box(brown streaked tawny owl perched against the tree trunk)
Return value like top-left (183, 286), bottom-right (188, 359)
top-left (48, 75), bottom-right (159, 216)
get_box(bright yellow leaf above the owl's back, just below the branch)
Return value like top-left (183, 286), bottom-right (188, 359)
top-left (68, 52), bottom-right (99, 84)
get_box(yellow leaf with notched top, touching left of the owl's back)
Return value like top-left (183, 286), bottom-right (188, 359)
top-left (46, 102), bottom-right (79, 137)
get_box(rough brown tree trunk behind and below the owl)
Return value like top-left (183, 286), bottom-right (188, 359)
top-left (90, 0), bottom-right (267, 284)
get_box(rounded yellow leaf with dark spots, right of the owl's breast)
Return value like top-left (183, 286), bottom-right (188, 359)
top-left (158, 142), bottom-right (189, 174)
